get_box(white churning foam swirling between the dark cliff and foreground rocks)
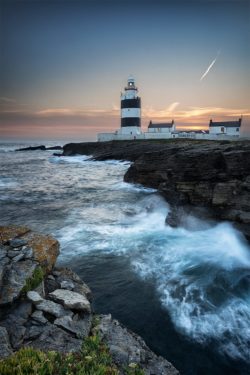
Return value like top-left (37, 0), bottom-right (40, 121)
top-left (57, 195), bottom-right (250, 361)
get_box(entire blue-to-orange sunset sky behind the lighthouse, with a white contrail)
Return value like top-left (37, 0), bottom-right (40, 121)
top-left (0, 0), bottom-right (250, 141)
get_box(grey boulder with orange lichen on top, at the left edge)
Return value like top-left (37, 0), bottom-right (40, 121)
top-left (0, 226), bottom-right (59, 306)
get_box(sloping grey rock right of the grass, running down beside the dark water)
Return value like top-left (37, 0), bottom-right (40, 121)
top-left (95, 315), bottom-right (179, 375)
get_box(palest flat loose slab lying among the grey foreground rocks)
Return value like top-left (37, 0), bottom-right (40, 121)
top-left (49, 289), bottom-right (91, 313)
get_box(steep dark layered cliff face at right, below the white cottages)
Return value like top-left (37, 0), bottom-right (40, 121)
top-left (124, 141), bottom-right (250, 238)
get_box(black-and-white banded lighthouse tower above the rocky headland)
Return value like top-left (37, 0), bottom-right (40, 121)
top-left (119, 76), bottom-right (142, 139)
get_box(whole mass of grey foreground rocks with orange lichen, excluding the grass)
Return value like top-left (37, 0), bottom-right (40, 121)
top-left (0, 226), bottom-right (179, 375)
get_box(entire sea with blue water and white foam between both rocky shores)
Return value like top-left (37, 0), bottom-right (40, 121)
top-left (0, 142), bottom-right (250, 375)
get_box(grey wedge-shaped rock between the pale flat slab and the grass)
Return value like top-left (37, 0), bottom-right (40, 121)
top-left (54, 314), bottom-right (92, 339)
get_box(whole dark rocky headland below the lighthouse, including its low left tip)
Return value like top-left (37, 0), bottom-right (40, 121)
top-left (62, 140), bottom-right (250, 240)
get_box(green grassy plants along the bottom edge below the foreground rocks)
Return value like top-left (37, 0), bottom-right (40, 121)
top-left (0, 334), bottom-right (144, 375)
